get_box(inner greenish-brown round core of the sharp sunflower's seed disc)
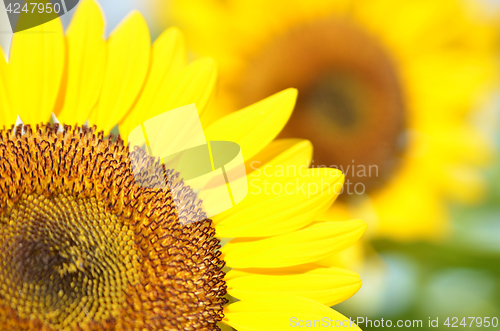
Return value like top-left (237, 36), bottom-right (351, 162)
top-left (0, 194), bottom-right (139, 328)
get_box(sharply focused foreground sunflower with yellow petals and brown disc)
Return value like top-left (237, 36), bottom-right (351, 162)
top-left (0, 0), bottom-right (366, 330)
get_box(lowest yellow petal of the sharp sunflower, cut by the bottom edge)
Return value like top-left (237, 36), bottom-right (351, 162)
top-left (223, 295), bottom-right (361, 331)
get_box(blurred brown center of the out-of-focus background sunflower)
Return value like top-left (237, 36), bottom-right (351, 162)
top-left (241, 19), bottom-right (405, 195)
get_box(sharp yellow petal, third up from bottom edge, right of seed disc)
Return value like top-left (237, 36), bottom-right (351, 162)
top-left (221, 220), bottom-right (366, 268)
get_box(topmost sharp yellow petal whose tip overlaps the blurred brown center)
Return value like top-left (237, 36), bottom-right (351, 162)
top-left (205, 89), bottom-right (297, 160)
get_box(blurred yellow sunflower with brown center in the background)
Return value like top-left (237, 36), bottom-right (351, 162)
top-left (167, 0), bottom-right (496, 240)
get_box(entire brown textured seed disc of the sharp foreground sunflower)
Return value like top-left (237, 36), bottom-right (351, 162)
top-left (0, 125), bottom-right (226, 330)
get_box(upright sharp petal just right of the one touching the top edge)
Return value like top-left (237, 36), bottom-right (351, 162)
top-left (90, 11), bottom-right (151, 132)
